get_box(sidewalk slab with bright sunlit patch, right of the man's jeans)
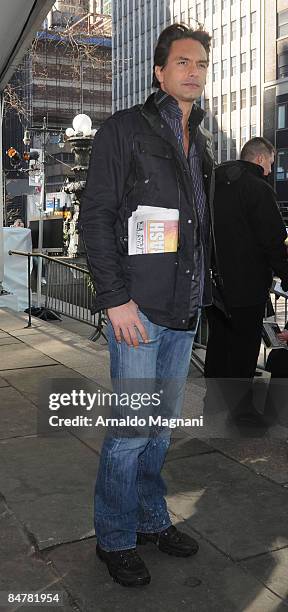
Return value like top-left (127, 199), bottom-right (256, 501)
top-left (163, 453), bottom-right (288, 560)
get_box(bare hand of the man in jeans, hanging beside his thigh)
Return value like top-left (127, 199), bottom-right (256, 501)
top-left (107, 300), bottom-right (149, 348)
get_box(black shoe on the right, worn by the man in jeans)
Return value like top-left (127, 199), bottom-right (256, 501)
top-left (137, 525), bottom-right (199, 557)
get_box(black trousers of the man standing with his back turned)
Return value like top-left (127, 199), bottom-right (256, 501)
top-left (204, 304), bottom-right (265, 424)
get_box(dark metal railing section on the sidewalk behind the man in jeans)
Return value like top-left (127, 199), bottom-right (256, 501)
top-left (9, 251), bottom-right (106, 341)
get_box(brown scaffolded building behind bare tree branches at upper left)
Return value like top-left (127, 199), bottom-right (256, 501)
top-left (31, 2), bottom-right (112, 128)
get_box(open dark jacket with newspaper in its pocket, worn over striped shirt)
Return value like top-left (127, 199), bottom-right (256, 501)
top-left (80, 94), bottom-right (214, 329)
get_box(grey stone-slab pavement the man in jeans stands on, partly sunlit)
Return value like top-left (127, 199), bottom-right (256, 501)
top-left (0, 309), bottom-right (288, 612)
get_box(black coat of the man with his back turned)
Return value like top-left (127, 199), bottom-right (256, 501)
top-left (214, 160), bottom-right (288, 306)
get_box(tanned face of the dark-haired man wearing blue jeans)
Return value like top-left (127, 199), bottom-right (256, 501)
top-left (155, 38), bottom-right (208, 103)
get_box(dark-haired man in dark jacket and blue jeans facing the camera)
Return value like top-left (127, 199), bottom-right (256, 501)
top-left (81, 24), bottom-right (213, 586)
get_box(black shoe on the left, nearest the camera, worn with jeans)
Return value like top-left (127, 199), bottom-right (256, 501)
top-left (96, 544), bottom-right (151, 586)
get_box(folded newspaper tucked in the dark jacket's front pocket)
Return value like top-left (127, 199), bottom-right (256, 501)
top-left (128, 206), bottom-right (179, 255)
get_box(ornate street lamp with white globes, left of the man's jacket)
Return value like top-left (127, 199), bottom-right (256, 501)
top-left (64, 113), bottom-right (97, 258)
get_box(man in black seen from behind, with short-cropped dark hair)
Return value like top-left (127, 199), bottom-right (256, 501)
top-left (205, 137), bottom-right (288, 425)
